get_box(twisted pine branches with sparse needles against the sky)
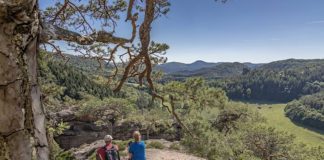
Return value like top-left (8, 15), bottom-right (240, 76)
top-left (41, 0), bottom-right (170, 91)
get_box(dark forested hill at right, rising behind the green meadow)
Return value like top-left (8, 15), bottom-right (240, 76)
top-left (211, 59), bottom-right (324, 102)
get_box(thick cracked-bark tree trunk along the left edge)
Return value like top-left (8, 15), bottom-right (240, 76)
top-left (0, 0), bottom-right (49, 160)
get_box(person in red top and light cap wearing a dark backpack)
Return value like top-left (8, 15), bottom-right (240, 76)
top-left (96, 135), bottom-right (120, 160)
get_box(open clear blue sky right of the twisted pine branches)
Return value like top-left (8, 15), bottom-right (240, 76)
top-left (41, 0), bottom-right (324, 63)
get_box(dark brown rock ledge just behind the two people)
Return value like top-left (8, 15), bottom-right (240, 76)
top-left (51, 109), bottom-right (179, 150)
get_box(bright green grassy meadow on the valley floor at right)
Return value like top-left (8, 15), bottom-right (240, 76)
top-left (251, 104), bottom-right (324, 147)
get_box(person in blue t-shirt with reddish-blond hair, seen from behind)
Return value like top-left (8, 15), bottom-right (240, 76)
top-left (128, 131), bottom-right (146, 160)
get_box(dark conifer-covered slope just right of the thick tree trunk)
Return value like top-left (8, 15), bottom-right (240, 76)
top-left (38, 52), bottom-right (123, 100)
